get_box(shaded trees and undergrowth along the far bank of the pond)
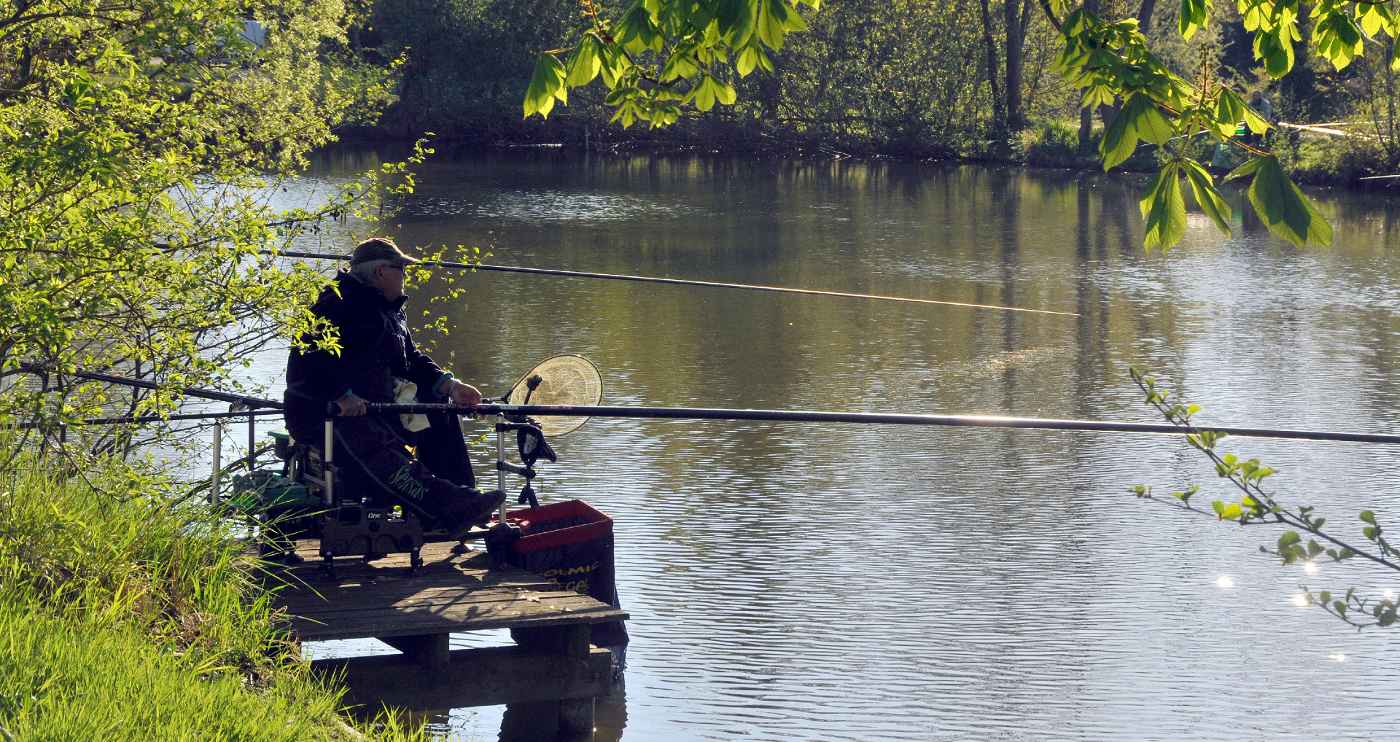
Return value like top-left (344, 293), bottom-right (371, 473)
top-left (351, 0), bottom-right (1400, 161)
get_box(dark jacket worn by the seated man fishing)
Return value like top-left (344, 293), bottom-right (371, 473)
top-left (284, 272), bottom-right (451, 435)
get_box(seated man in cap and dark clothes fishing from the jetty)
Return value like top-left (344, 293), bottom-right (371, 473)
top-left (284, 237), bottom-right (505, 535)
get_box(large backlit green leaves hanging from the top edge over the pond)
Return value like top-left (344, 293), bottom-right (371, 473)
top-left (525, 0), bottom-right (1400, 249)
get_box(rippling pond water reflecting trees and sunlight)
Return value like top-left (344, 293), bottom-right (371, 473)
top-left (259, 151), bottom-right (1400, 741)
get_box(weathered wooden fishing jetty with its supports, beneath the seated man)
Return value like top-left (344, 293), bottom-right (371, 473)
top-left (273, 540), bottom-right (627, 738)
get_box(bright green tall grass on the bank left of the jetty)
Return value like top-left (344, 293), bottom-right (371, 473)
top-left (0, 455), bottom-right (414, 741)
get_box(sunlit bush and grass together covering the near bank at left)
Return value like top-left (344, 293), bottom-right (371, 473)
top-left (0, 0), bottom-right (431, 739)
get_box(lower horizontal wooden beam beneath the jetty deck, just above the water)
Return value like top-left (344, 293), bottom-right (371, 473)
top-left (311, 647), bottom-right (612, 710)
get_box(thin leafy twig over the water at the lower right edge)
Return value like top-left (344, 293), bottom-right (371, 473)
top-left (1128, 368), bottom-right (1400, 629)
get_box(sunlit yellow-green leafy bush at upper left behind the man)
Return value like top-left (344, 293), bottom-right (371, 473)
top-left (0, 0), bottom-right (417, 448)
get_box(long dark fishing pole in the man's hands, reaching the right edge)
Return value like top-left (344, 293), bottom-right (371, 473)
top-left (367, 403), bottom-right (1400, 444)
